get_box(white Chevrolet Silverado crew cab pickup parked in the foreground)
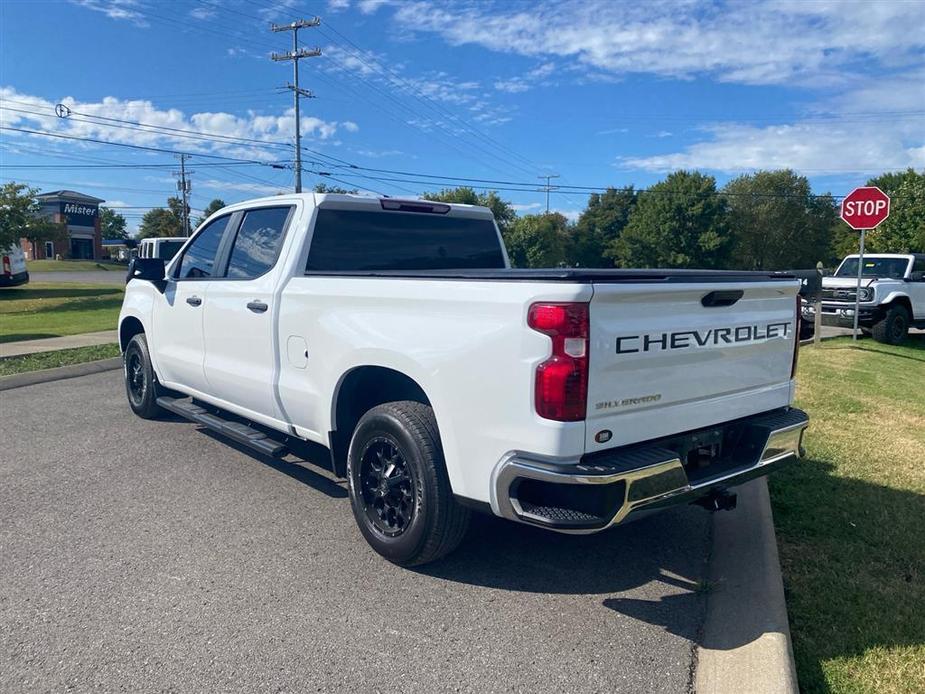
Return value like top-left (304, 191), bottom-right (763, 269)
top-left (119, 194), bottom-right (808, 565)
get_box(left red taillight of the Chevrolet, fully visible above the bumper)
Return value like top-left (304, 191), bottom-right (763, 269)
top-left (527, 303), bottom-right (588, 422)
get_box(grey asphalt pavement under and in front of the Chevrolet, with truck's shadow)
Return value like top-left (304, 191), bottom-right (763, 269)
top-left (0, 371), bottom-right (710, 692)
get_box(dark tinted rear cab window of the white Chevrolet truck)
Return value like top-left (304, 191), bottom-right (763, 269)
top-left (305, 207), bottom-right (505, 273)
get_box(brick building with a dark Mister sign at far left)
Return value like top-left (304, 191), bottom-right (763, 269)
top-left (20, 190), bottom-right (105, 260)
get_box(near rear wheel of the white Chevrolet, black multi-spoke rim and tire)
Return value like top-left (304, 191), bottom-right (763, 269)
top-left (347, 401), bottom-right (469, 566)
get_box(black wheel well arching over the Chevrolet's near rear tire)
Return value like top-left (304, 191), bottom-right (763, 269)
top-left (328, 366), bottom-right (430, 477)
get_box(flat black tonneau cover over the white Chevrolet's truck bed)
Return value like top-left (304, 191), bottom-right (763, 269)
top-left (305, 268), bottom-right (796, 284)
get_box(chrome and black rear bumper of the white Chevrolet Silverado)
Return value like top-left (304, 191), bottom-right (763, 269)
top-left (491, 408), bottom-right (809, 533)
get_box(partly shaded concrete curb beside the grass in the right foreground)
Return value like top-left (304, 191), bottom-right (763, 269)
top-left (694, 478), bottom-right (798, 694)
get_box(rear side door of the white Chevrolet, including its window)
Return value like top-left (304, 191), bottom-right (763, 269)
top-left (203, 205), bottom-right (295, 419)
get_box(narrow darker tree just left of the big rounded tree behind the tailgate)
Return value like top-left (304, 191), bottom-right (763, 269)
top-left (568, 186), bottom-right (636, 267)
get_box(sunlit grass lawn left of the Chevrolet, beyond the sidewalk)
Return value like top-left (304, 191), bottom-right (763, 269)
top-left (0, 282), bottom-right (123, 343)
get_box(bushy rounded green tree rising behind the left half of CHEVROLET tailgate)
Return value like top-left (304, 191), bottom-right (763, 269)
top-left (613, 171), bottom-right (732, 268)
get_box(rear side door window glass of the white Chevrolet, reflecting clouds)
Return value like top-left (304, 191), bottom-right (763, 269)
top-left (226, 206), bottom-right (292, 279)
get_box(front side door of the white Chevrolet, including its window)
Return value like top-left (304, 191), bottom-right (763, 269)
top-left (151, 215), bottom-right (231, 391)
